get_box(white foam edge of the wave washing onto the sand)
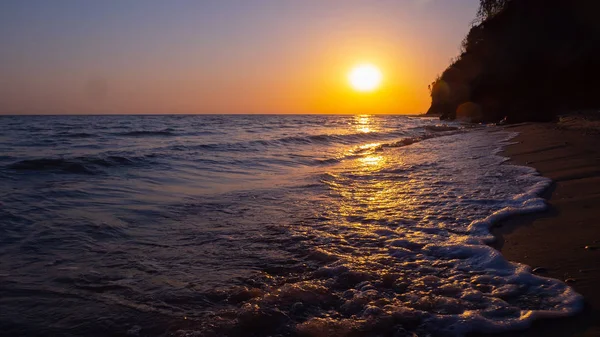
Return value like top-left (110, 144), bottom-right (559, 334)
top-left (414, 129), bottom-right (583, 336)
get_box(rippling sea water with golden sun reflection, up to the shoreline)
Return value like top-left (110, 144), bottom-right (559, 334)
top-left (0, 115), bottom-right (582, 336)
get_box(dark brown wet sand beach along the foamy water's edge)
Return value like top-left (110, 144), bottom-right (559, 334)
top-left (482, 123), bottom-right (600, 337)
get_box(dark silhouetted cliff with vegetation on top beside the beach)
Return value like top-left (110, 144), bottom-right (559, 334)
top-left (428, 0), bottom-right (600, 122)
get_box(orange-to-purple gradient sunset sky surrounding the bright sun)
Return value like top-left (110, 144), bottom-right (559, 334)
top-left (0, 0), bottom-right (479, 114)
